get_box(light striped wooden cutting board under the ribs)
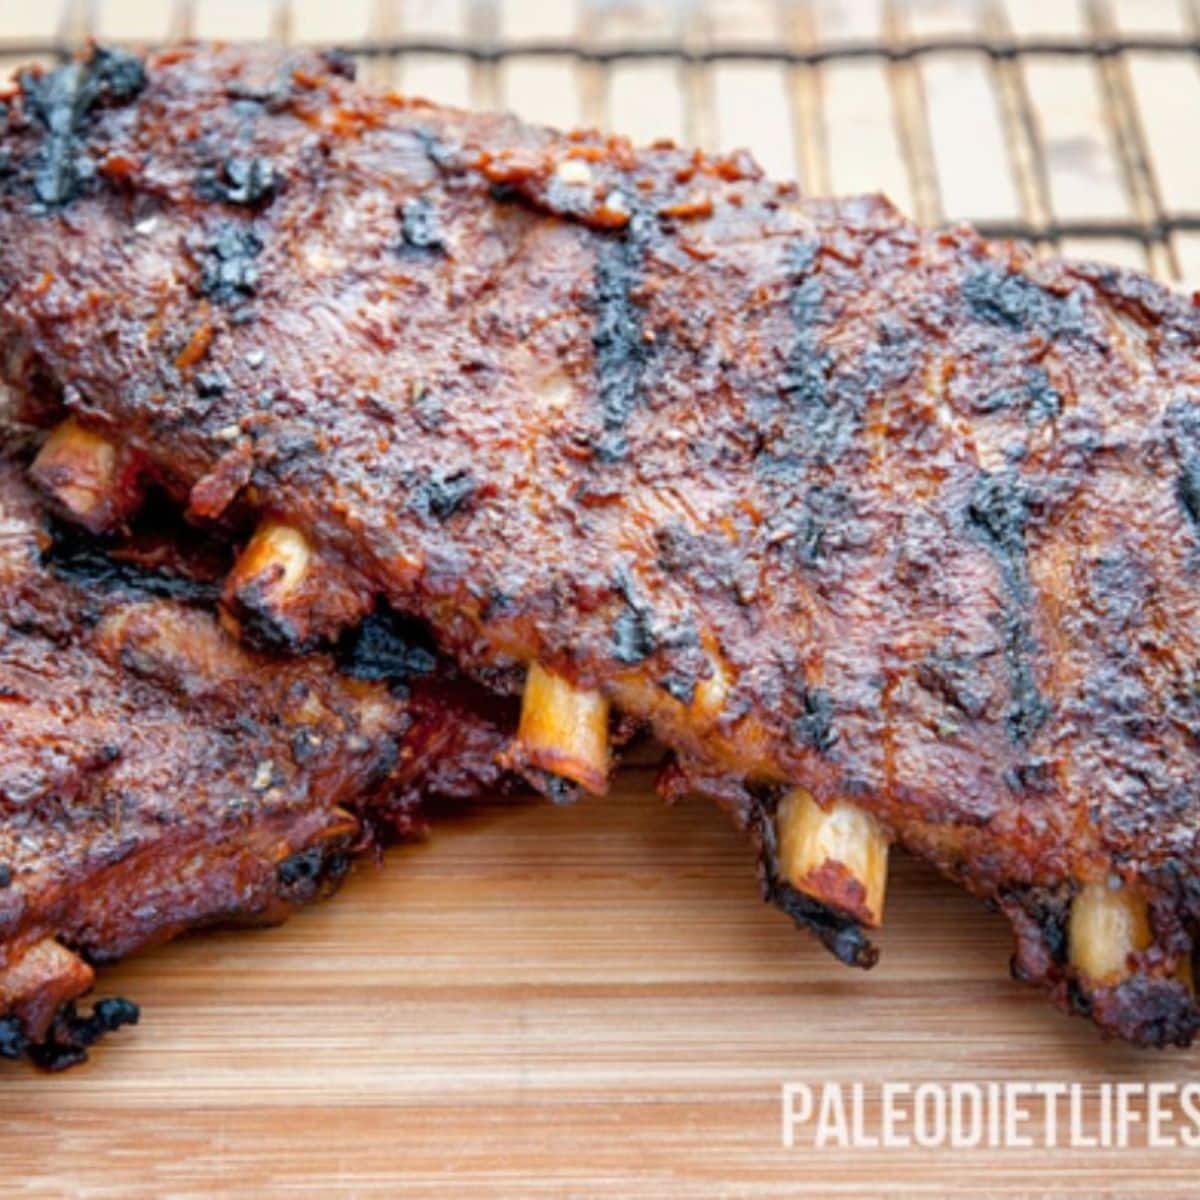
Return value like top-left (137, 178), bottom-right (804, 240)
top-left (0, 769), bottom-right (1198, 1200)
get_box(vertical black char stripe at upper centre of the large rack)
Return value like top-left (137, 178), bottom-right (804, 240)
top-left (592, 216), bottom-right (648, 463)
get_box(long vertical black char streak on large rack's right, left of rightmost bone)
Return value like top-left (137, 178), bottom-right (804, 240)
top-left (966, 472), bottom-right (1050, 744)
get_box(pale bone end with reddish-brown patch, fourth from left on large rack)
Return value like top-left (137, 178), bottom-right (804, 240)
top-left (775, 787), bottom-right (888, 928)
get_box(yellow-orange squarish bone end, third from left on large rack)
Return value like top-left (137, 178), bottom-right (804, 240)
top-left (508, 662), bottom-right (610, 794)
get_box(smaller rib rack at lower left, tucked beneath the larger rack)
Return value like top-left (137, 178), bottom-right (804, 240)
top-left (0, 463), bottom-right (513, 1067)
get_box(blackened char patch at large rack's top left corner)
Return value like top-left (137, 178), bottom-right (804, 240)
top-left (20, 46), bottom-right (146, 208)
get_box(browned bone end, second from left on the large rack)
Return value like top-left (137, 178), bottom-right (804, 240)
top-left (223, 518), bottom-right (371, 649)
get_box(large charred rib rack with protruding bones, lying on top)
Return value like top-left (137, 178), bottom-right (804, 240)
top-left (0, 48), bottom-right (1200, 1044)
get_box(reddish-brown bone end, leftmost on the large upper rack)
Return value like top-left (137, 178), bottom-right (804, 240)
top-left (30, 416), bottom-right (142, 533)
